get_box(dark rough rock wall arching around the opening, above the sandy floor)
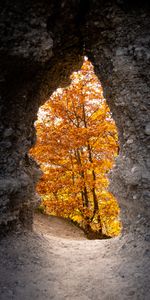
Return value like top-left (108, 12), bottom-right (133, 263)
top-left (0, 0), bottom-right (150, 237)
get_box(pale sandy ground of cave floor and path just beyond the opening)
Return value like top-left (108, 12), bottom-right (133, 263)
top-left (0, 215), bottom-right (150, 300)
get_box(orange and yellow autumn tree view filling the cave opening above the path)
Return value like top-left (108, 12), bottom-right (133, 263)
top-left (31, 57), bottom-right (121, 238)
